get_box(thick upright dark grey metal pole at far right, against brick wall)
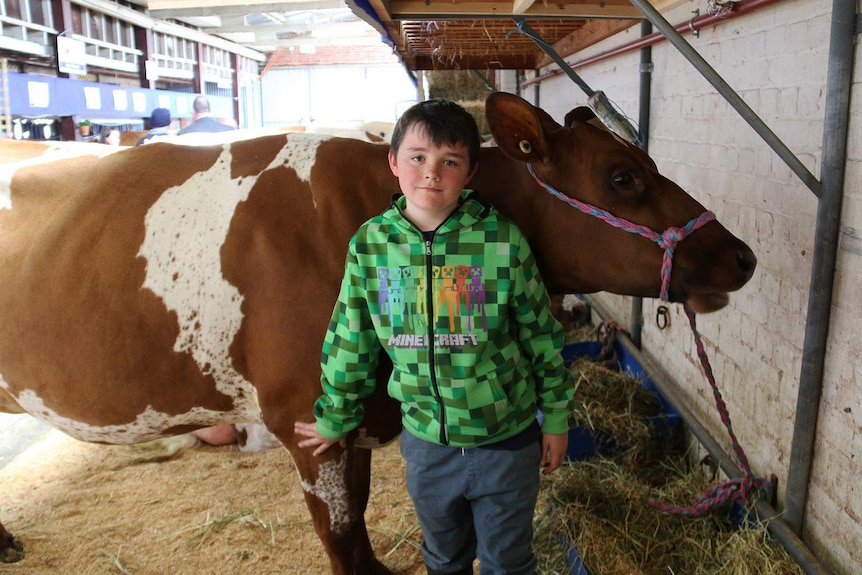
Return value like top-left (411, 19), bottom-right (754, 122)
top-left (784, 0), bottom-right (856, 534)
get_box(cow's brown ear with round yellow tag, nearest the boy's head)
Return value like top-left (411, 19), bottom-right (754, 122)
top-left (485, 92), bottom-right (560, 164)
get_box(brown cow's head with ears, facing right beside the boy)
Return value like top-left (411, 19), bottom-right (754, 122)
top-left (486, 92), bottom-right (757, 313)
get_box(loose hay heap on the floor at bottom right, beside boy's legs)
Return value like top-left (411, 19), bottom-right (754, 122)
top-left (534, 458), bottom-right (802, 575)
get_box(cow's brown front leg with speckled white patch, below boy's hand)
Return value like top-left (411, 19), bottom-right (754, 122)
top-left (291, 446), bottom-right (391, 575)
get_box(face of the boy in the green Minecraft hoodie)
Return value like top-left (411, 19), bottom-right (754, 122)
top-left (389, 124), bottom-right (476, 231)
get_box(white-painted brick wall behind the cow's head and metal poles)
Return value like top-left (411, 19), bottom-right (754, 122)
top-left (523, 0), bottom-right (862, 575)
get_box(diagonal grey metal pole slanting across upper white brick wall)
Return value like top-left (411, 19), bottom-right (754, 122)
top-left (631, 0), bottom-right (824, 197)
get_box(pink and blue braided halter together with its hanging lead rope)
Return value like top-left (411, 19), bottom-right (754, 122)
top-left (527, 164), bottom-right (772, 517)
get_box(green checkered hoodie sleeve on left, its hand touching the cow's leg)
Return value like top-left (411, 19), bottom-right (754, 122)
top-left (314, 238), bottom-right (381, 440)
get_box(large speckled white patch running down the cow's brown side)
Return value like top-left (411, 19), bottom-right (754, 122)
top-left (138, 136), bottom-right (329, 421)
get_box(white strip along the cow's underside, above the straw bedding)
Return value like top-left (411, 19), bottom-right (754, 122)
top-left (2, 390), bottom-right (255, 444)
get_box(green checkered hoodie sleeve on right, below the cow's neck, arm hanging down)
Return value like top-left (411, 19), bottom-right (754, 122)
top-left (513, 234), bottom-right (575, 434)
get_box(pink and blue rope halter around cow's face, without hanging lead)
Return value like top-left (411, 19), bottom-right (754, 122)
top-left (527, 164), bottom-right (715, 301)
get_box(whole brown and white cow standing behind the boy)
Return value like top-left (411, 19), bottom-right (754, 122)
top-left (0, 94), bottom-right (755, 575)
